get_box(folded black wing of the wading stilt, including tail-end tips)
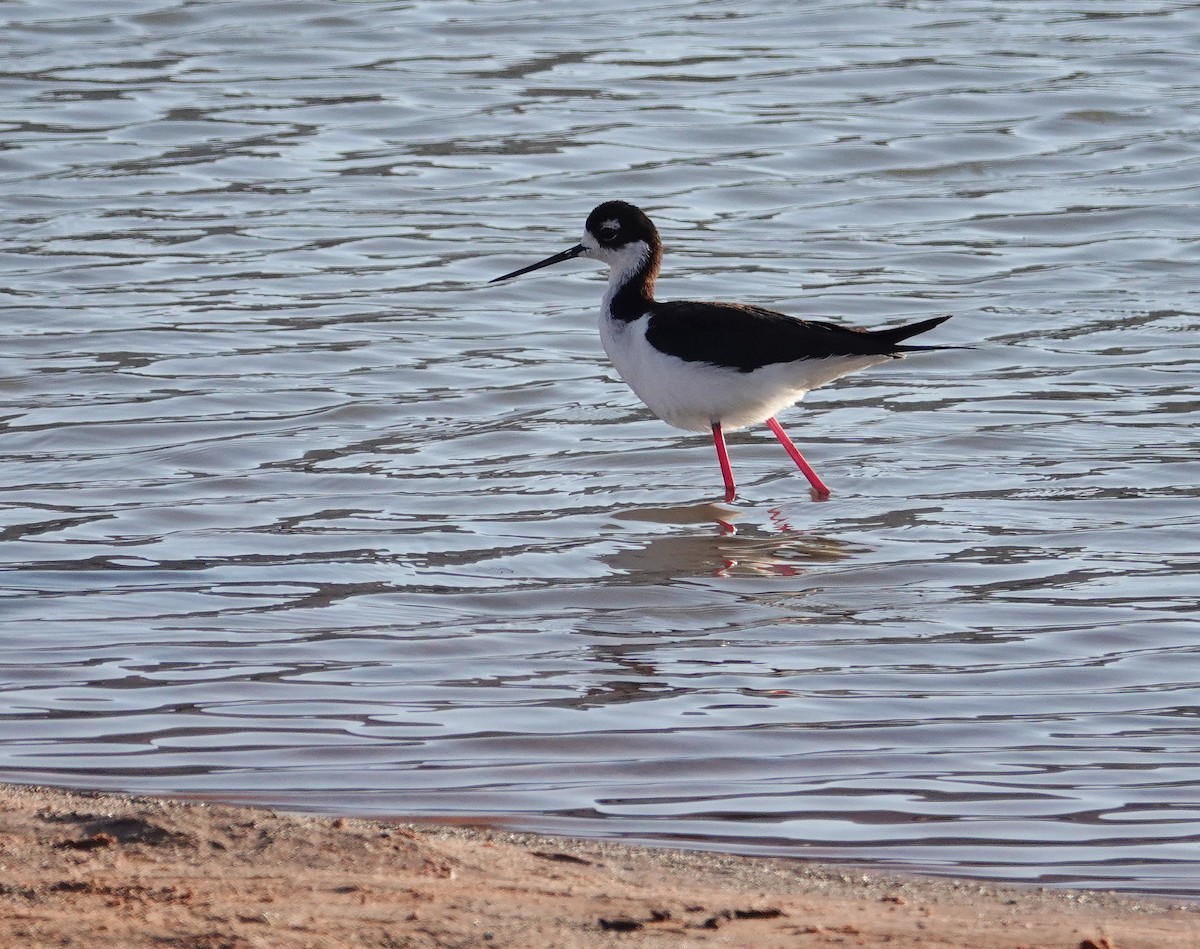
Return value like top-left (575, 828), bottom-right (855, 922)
top-left (646, 301), bottom-right (949, 372)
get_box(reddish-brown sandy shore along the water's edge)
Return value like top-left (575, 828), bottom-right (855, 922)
top-left (0, 785), bottom-right (1200, 949)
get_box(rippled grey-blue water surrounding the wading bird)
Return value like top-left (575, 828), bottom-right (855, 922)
top-left (0, 0), bottom-right (1200, 895)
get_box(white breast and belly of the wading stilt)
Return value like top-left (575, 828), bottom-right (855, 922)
top-left (600, 307), bottom-right (888, 432)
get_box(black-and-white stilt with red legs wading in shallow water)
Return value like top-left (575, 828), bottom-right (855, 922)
top-left (491, 202), bottom-right (949, 501)
